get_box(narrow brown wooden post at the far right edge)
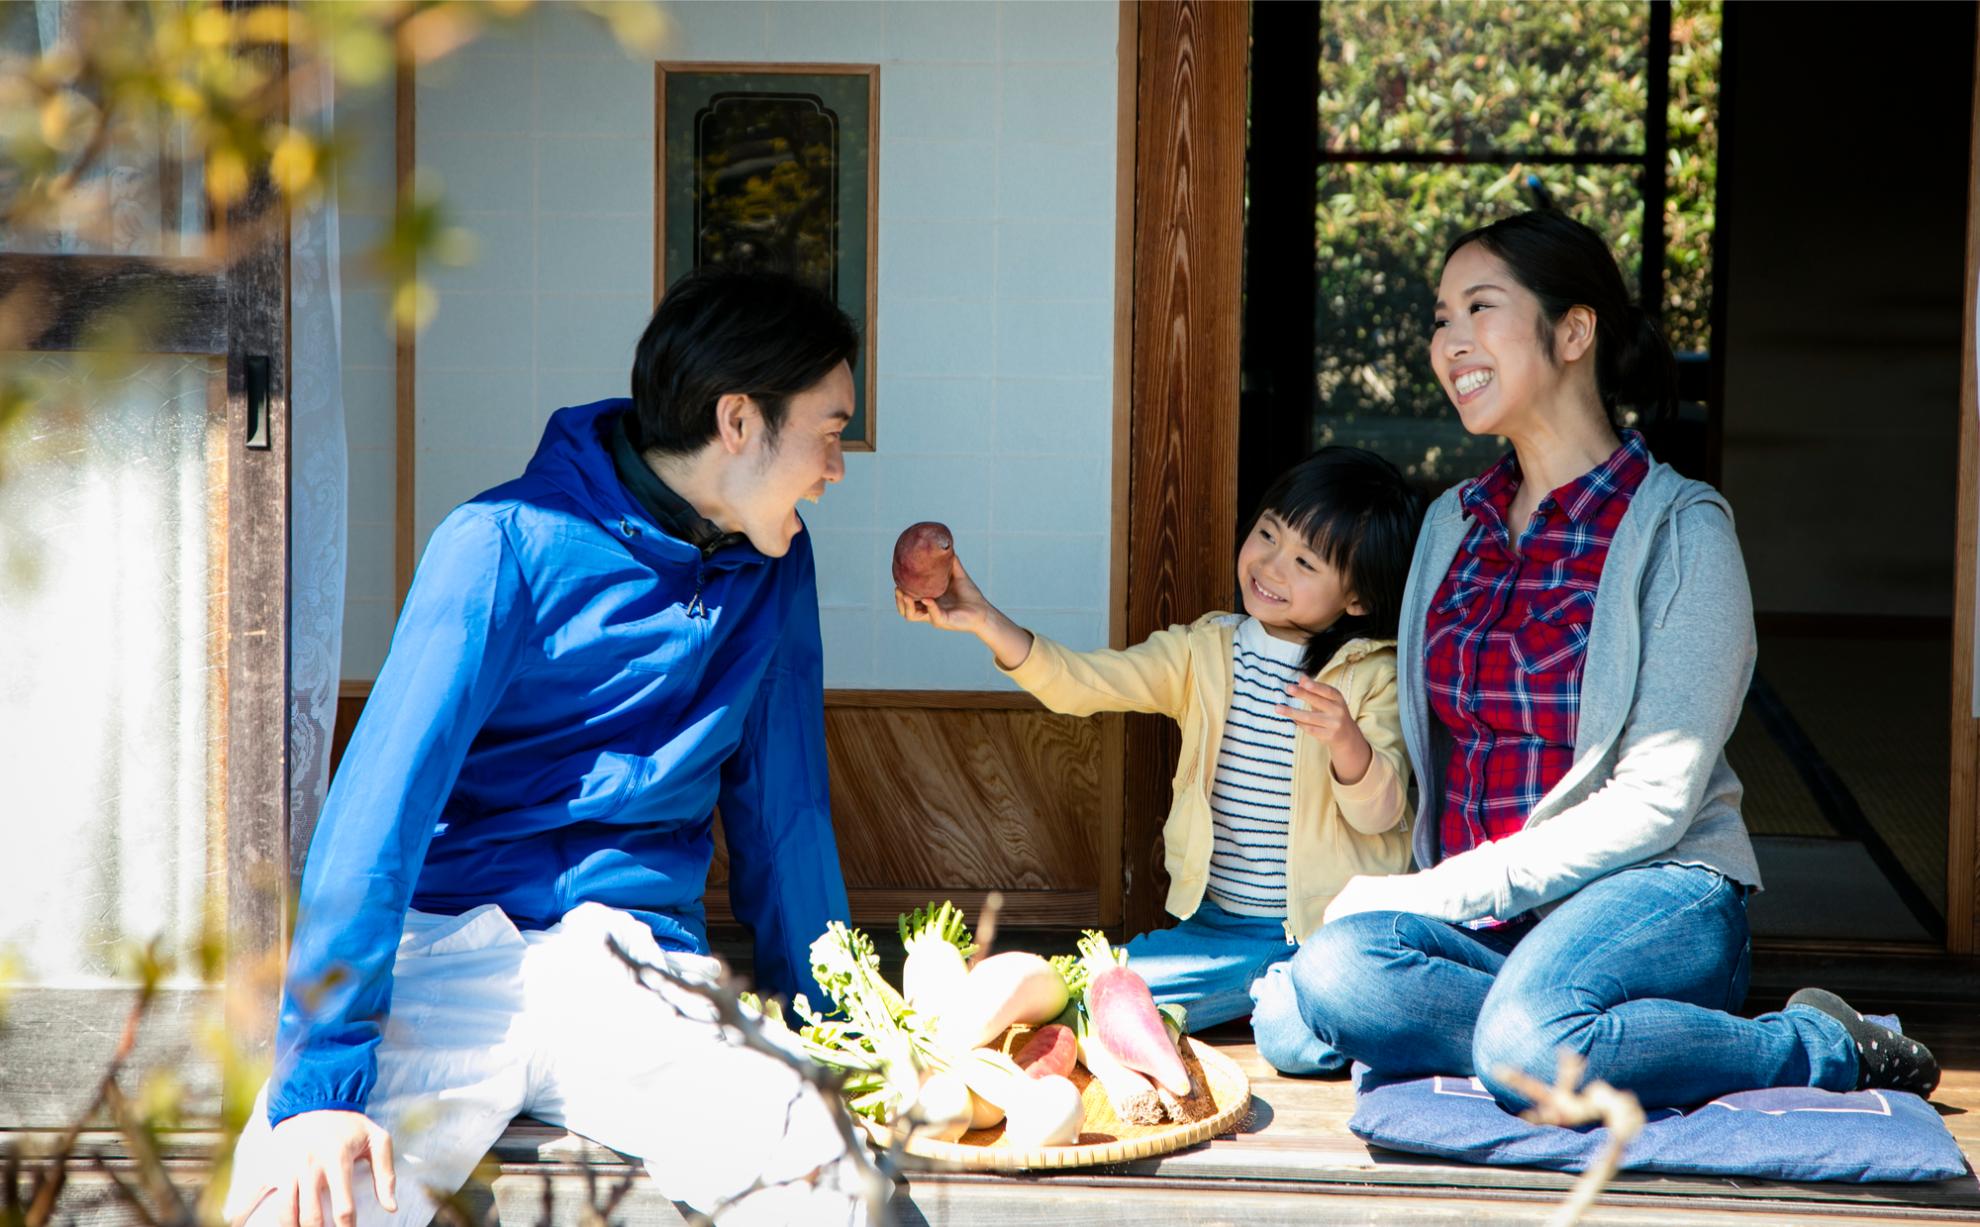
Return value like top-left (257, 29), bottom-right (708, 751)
top-left (1946, 19), bottom-right (1980, 954)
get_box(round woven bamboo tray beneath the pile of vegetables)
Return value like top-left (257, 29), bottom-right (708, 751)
top-left (867, 1039), bottom-right (1251, 1172)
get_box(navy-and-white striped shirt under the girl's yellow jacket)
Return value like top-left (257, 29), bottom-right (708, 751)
top-left (1208, 617), bottom-right (1307, 918)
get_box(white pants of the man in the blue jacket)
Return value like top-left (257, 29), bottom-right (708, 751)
top-left (226, 902), bottom-right (863, 1227)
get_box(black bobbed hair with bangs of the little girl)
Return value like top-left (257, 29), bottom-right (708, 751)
top-left (1238, 445), bottom-right (1424, 677)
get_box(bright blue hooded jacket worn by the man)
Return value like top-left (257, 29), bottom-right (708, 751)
top-left (267, 400), bottom-right (845, 1124)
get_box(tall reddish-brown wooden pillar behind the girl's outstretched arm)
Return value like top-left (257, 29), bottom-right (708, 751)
top-left (1123, 0), bottom-right (1251, 932)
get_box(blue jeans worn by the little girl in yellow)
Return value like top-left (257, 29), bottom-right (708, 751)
top-left (1127, 898), bottom-right (1346, 1073)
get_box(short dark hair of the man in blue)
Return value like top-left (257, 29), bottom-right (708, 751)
top-left (628, 267), bottom-right (859, 455)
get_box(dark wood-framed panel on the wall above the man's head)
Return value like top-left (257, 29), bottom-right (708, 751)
top-left (653, 63), bottom-right (879, 451)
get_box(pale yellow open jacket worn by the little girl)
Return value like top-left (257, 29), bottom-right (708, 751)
top-left (1006, 614), bottom-right (1410, 942)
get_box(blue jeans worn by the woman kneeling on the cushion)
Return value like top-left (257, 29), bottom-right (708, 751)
top-left (1291, 863), bottom-right (1857, 1108)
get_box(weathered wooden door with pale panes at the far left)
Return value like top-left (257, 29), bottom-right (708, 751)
top-left (0, 0), bottom-right (289, 1128)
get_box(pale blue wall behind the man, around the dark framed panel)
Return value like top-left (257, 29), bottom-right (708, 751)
top-left (403, 0), bottom-right (1119, 689)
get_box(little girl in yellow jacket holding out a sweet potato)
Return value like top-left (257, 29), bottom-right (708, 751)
top-left (895, 447), bottom-right (1422, 1073)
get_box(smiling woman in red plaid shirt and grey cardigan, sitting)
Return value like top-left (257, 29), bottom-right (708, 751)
top-left (1291, 212), bottom-right (1938, 1106)
